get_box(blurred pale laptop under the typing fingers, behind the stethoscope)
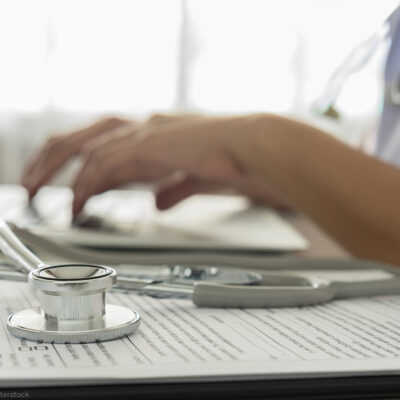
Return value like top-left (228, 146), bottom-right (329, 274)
top-left (0, 185), bottom-right (308, 252)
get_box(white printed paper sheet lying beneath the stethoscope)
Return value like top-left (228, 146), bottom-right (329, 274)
top-left (0, 271), bottom-right (400, 387)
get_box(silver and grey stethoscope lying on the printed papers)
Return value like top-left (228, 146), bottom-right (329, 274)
top-left (0, 221), bottom-right (400, 343)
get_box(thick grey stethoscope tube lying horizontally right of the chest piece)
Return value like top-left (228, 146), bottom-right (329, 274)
top-left (0, 250), bottom-right (400, 308)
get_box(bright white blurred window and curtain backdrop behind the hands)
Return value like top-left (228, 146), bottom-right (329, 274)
top-left (0, 0), bottom-right (398, 183)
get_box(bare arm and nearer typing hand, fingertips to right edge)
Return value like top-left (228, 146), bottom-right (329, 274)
top-left (25, 114), bottom-right (400, 265)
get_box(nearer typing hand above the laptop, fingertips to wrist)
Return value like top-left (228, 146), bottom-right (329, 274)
top-left (73, 117), bottom-right (288, 214)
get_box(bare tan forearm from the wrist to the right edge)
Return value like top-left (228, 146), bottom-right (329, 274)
top-left (231, 115), bottom-right (400, 264)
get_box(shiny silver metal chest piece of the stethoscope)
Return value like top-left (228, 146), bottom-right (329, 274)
top-left (7, 264), bottom-right (140, 343)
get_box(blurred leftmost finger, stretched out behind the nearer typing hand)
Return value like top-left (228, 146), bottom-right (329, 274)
top-left (21, 118), bottom-right (128, 197)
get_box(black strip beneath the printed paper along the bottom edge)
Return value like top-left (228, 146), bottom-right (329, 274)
top-left (21, 376), bottom-right (400, 400)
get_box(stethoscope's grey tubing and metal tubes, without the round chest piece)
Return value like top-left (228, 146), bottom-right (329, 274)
top-left (0, 221), bottom-right (400, 308)
